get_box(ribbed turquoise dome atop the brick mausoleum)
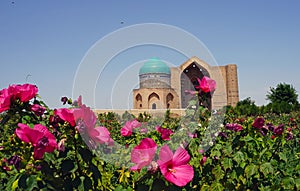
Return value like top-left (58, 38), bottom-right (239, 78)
top-left (139, 58), bottom-right (171, 74)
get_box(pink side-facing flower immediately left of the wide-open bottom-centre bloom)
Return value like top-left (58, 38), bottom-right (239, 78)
top-left (130, 138), bottom-right (157, 171)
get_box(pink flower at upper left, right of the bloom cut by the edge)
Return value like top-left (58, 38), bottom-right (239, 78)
top-left (8, 84), bottom-right (38, 102)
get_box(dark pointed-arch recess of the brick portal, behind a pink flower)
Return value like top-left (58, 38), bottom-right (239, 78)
top-left (180, 62), bottom-right (211, 109)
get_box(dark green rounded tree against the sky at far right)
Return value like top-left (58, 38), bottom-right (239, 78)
top-left (267, 83), bottom-right (298, 105)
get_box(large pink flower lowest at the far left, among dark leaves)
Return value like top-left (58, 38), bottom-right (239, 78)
top-left (15, 123), bottom-right (57, 160)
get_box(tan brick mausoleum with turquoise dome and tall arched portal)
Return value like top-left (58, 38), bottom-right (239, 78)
top-left (133, 57), bottom-right (239, 109)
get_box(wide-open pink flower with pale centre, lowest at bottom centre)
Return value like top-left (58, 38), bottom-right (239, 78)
top-left (157, 145), bottom-right (194, 186)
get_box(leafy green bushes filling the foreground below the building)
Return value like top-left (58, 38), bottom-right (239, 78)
top-left (0, 83), bottom-right (300, 191)
